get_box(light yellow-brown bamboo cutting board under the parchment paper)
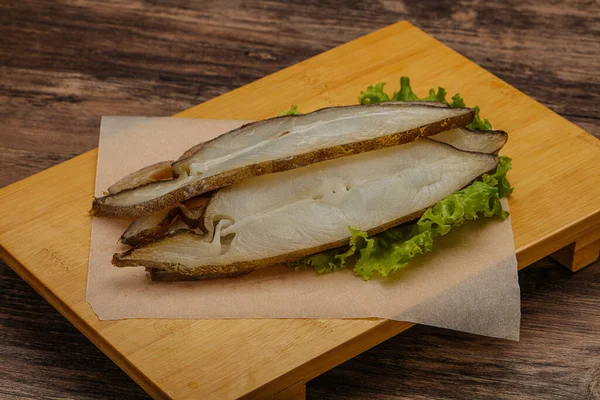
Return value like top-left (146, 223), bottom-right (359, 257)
top-left (0, 22), bottom-right (600, 399)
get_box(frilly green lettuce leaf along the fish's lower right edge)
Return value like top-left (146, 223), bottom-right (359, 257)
top-left (294, 157), bottom-right (512, 280)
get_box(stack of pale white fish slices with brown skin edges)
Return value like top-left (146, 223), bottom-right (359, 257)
top-left (92, 101), bottom-right (507, 280)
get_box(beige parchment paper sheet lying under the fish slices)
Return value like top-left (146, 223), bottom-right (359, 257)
top-left (87, 117), bottom-right (520, 340)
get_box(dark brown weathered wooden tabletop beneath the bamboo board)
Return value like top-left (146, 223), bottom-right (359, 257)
top-left (0, 0), bottom-right (600, 400)
